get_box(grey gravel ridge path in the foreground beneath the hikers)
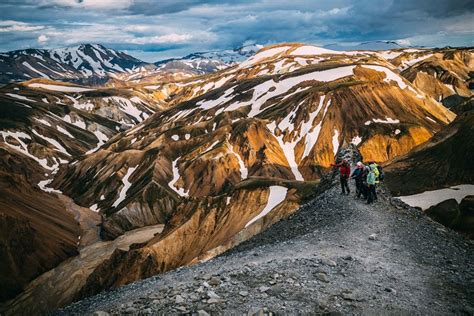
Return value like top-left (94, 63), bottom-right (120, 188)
top-left (57, 179), bottom-right (474, 315)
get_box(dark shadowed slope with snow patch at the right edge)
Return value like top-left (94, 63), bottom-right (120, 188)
top-left (384, 110), bottom-right (474, 238)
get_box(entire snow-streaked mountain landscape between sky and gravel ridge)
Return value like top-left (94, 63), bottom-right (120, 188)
top-left (0, 43), bottom-right (474, 313)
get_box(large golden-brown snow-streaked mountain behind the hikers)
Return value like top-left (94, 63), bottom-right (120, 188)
top-left (37, 44), bottom-right (454, 306)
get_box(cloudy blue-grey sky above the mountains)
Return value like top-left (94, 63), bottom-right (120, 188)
top-left (0, 0), bottom-right (474, 61)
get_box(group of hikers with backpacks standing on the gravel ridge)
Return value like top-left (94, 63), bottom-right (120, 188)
top-left (331, 159), bottom-right (384, 204)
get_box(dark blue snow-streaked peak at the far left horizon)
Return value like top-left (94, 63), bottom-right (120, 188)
top-left (0, 44), bottom-right (147, 84)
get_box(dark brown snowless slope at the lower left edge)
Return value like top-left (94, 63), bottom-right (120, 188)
top-left (0, 143), bottom-right (81, 301)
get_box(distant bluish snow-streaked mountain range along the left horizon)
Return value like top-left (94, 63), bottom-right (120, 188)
top-left (0, 44), bottom-right (261, 85)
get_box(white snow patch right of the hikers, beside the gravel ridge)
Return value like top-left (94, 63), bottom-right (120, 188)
top-left (397, 184), bottom-right (474, 210)
